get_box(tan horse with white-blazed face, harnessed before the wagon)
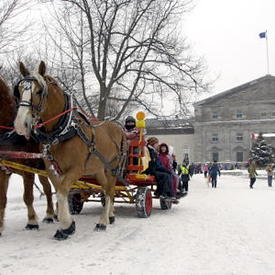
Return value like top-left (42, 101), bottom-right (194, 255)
top-left (14, 61), bottom-right (126, 240)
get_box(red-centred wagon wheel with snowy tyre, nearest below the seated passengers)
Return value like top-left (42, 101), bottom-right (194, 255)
top-left (136, 187), bottom-right (153, 218)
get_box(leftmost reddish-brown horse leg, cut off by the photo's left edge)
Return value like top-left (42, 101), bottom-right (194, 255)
top-left (0, 170), bottom-right (10, 236)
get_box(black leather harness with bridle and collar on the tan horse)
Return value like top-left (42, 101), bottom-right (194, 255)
top-left (14, 77), bottom-right (124, 179)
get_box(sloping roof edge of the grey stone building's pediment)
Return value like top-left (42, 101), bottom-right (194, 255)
top-left (194, 74), bottom-right (275, 107)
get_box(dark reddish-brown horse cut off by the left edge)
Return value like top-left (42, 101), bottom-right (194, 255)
top-left (0, 77), bottom-right (54, 235)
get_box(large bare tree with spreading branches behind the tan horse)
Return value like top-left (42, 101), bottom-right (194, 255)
top-left (41, 0), bottom-right (207, 119)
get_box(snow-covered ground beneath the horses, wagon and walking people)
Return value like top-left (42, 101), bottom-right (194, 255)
top-left (0, 175), bottom-right (275, 275)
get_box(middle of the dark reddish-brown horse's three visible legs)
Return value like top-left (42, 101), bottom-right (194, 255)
top-left (23, 173), bottom-right (39, 230)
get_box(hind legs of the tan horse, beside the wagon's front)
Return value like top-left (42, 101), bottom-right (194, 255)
top-left (95, 174), bottom-right (116, 231)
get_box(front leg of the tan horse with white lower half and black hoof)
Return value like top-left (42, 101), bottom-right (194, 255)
top-left (51, 175), bottom-right (78, 240)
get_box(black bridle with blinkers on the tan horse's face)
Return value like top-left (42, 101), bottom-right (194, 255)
top-left (14, 76), bottom-right (47, 113)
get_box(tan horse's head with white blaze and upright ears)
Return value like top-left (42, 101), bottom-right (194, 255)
top-left (14, 61), bottom-right (51, 138)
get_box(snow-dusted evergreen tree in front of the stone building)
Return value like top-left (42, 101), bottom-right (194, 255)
top-left (249, 133), bottom-right (274, 167)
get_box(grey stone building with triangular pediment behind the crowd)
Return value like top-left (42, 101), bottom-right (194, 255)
top-left (193, 75), bottom-right (275, 162)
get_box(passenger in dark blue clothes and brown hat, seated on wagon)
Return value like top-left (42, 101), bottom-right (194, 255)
top-left (144, 137), bottom-right (178, 202)
